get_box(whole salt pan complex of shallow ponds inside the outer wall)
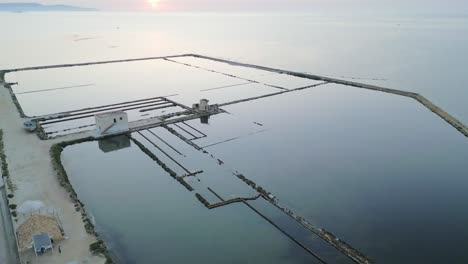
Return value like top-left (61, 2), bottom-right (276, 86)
top-left (6, 55), bottom-right (468, 263)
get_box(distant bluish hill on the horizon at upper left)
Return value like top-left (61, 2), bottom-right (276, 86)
top-left (0, 3), bottom-right (98, 12)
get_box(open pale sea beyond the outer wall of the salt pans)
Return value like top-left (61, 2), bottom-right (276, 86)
top-left (0, 12), bottom-right (468, 123)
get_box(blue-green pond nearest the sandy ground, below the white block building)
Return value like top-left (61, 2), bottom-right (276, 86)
top-left (63, 142), bottom-right (326, 264)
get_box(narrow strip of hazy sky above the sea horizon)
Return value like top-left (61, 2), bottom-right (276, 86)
top-left (6, 0), bottom-right (468, 13)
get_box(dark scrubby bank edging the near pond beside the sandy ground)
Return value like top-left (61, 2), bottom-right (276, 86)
top-left (49, 136), bottom-right (114, 264)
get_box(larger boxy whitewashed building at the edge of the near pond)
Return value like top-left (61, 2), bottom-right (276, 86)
top-left (94, 111), bottom-right (129, 135)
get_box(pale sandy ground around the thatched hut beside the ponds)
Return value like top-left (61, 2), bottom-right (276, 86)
top-left (0, 84), bottom-right (105, 264)
